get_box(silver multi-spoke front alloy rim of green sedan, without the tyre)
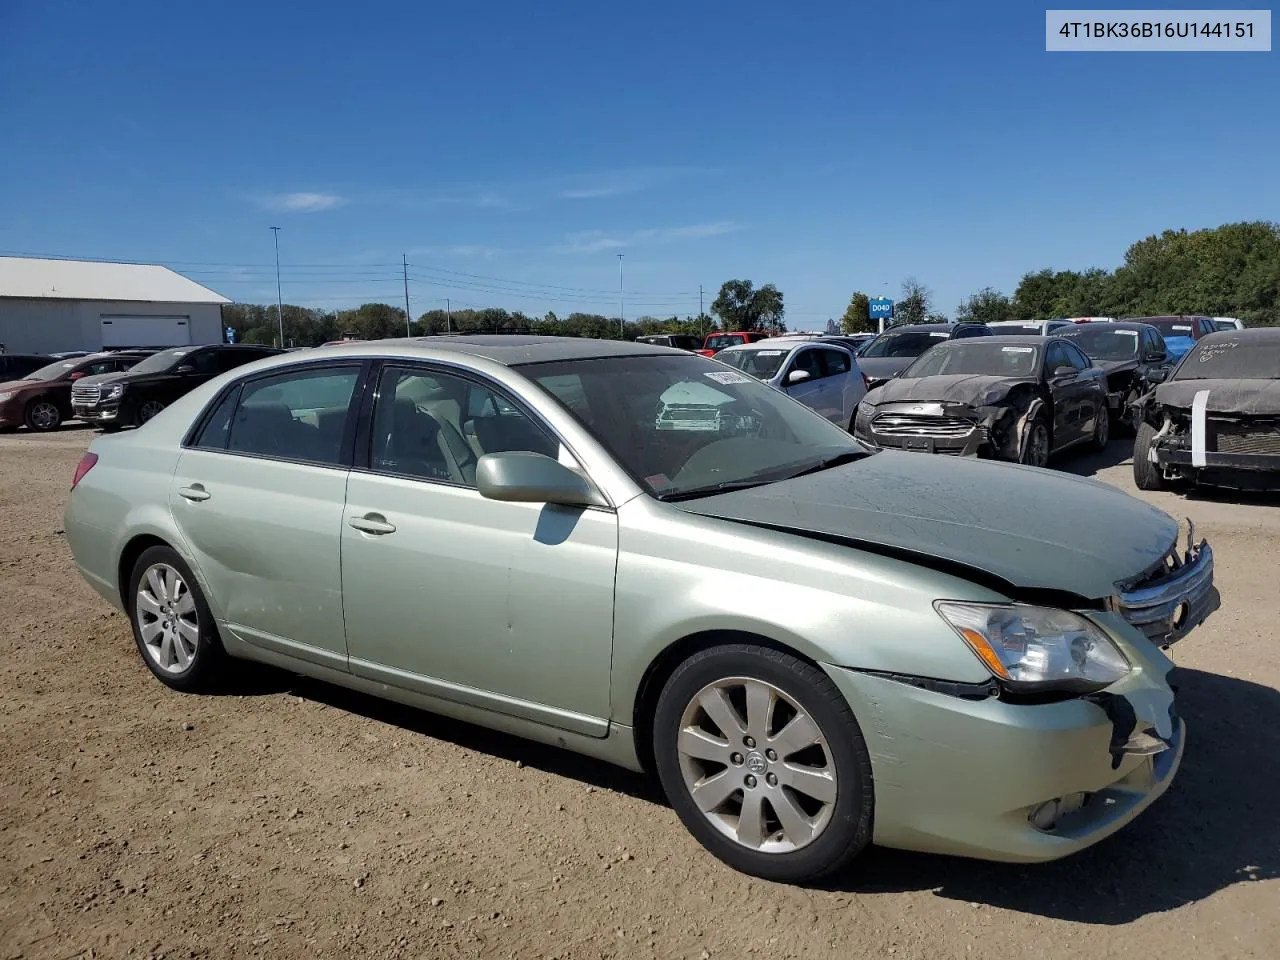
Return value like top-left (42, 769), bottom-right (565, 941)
top-left (676, 677), bottom-right (838, 854)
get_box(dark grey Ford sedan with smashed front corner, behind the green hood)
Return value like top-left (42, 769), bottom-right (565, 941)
top-left (854, 337), bottom-right (1111, 467)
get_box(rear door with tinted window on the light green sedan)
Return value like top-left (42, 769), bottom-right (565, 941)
top-left (169, 360), bottom-right (362, 671)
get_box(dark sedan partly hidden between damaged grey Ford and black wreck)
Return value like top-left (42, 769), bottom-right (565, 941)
top-left (1057, 321), bottom-right (1174, 431)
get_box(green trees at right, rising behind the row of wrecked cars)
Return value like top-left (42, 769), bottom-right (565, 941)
top-left (841, 220), bottom-right (1280, 333)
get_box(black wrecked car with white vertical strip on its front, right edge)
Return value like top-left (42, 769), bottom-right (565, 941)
top-left (1133, 328), bottom-right (1280, 490)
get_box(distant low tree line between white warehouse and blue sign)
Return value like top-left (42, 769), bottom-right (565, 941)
top-left (223, 280), bottom-right (786, 347)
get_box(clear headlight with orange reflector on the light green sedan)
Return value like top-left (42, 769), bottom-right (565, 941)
top-left (937, 603), bottom-right (1129, 692)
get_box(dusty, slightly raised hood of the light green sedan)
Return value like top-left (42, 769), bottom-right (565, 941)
top-left (673, 451), bottom-right (1178, 600)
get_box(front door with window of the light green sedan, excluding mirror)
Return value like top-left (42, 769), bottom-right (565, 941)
top-left (342, 365), bottom-right (618, 736)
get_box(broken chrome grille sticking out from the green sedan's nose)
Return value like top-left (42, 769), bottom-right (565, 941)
top-left (1116, 540), bottom-right (1216, 646)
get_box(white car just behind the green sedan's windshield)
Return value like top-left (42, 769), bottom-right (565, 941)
top-left (716, 337), bottom-right (867, 430)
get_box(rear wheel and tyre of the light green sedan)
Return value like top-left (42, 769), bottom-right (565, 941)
top-left (128, 547), bottom-right (227, 692)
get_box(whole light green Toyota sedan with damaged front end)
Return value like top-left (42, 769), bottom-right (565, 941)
top-left (65, 337), bottom-right (1217, 882)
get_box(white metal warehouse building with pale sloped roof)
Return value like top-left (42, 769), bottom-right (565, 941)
top-left (0, 257), bottom-right (232, 353)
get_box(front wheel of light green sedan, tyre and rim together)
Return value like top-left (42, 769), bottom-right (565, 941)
top-left (653, 644), bottom-right (874, 883)
